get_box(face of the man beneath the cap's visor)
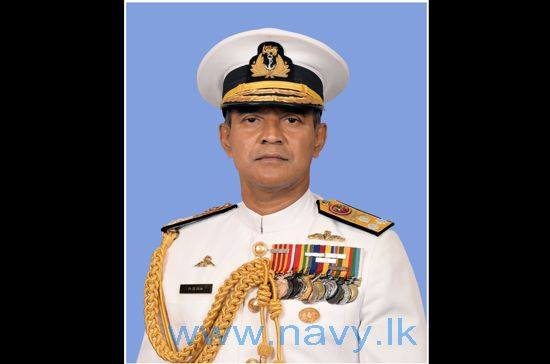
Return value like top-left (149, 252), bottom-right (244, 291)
top-left (220, 107), bottom-right (326, 189)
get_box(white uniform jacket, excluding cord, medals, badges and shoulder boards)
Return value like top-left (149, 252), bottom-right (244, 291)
top-left (138, 190), bottom-right (426, 363)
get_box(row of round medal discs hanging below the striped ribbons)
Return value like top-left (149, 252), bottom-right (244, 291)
top-left (275, 272), bottom-right (360, 305)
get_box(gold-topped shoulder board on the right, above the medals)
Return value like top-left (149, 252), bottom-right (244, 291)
top-left (317, 200), bottom-right (395, 236)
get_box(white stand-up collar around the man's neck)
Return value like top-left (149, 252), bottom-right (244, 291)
top-left (237, 189), bottom-right (320, 233)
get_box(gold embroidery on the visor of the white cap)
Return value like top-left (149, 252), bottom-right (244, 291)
top-left (221, 81), bottom-right (323, 107)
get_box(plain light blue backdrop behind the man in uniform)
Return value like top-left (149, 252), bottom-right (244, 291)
top-left (126, 3), bottom-right (426, 361)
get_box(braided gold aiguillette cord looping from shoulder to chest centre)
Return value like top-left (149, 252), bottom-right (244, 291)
top-left (144, 230), bottom-right (282, 363)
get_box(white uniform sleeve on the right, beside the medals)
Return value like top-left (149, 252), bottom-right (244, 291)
top-left (359, 230), bottom-right (426, 363)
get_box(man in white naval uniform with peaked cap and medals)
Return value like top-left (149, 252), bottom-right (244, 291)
top-left (138, 29), bottom-right (426, 362)
